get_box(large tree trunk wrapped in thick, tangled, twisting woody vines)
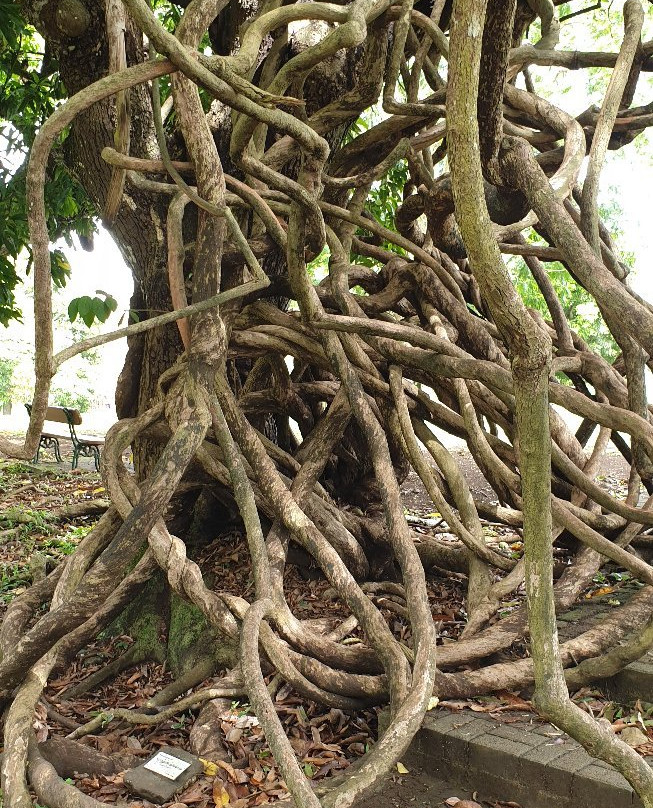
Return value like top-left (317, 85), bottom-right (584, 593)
top-left (0, 0), bottom-right (653, 806)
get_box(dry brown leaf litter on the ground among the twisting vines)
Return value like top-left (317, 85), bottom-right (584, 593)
top-left (0, 463), bottom-right (653, 808)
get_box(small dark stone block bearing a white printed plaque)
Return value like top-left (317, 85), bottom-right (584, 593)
top-left (125, 746), bottom-right (204, 805)
